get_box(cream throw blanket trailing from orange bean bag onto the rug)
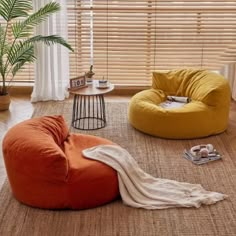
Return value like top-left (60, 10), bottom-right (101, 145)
top-left (83, 145), bottom-right (226, 209)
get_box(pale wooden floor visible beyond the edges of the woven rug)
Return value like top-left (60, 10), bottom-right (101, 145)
top-left (0, 95), bottom-right (130, 187)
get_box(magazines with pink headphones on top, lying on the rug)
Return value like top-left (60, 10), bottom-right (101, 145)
top-left (183, 144), bottom-right (222, 165)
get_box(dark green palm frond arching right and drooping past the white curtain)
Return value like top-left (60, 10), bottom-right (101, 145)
top-left (26, 35), bottom-right (74, 51)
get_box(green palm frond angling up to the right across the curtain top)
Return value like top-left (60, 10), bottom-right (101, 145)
top-left (12, 0), bottom-right (60, 38)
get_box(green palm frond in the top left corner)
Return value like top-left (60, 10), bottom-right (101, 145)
top-left (0, 0), bottom-right (32, 22)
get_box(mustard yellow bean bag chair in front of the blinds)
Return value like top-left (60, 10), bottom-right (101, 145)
top-left (129, 69), bottom-right (230, 139)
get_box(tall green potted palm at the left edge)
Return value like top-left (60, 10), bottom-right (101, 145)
top-left (0, 0), bottom-right (73, 110)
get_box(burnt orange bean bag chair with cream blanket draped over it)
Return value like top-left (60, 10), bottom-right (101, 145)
top-left (3, 116), bottom-right (119, 209)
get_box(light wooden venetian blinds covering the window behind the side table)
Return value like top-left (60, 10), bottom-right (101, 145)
top-left (68, 0), bottom-right (236, 85)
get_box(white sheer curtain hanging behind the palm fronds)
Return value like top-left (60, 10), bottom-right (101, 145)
top-left (31, 0), bottom-right (69, 102)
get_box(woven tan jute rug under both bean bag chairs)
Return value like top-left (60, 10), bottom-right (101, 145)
top-left (0, 100), bottom-right (236, 236)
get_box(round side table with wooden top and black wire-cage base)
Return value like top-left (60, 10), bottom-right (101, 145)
top-left (70, 80), bottom-right (114, 130)
